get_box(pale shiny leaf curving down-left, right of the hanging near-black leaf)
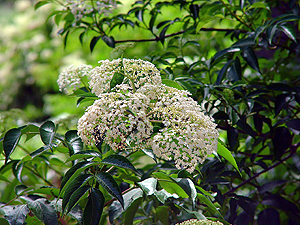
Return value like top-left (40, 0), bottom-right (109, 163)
top-left (108, 188), bottom-right (143, 224)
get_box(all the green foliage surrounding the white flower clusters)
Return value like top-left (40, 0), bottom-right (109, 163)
top-left (0, 0), bottom-right (300, 225)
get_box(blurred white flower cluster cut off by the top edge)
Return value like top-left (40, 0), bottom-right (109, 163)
top-left (66, 0), bottom-right (117, 21)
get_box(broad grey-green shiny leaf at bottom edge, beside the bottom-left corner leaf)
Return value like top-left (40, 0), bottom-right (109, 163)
top-left (27, 198), bottom-right (58, 225)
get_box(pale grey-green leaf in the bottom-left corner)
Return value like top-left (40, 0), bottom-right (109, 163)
top-left (2, 205), bottom-right (29, 225)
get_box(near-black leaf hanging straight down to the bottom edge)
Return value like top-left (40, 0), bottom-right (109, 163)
top-left (82, 188), bottom-right (105, 225)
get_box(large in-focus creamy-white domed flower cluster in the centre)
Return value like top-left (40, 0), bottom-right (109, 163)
top-left (60, 59), bottom-right (218, 173)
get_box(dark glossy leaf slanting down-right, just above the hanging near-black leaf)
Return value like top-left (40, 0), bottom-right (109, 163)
top-left (95, 172), bottom-right (124, 206)
